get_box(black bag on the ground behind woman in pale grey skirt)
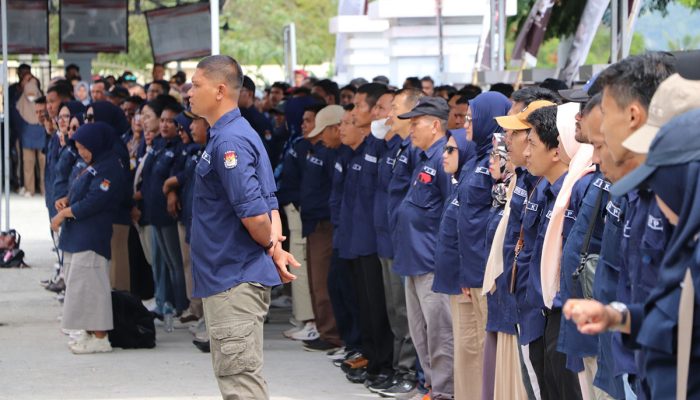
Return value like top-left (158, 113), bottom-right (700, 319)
top-left (109, 290), bottom-right (156, 349)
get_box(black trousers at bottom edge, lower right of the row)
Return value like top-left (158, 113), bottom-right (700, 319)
top-left (529, 308), bottom-right (581, 400)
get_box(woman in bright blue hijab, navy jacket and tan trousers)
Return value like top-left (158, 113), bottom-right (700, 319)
top-left (453, 92), bottom-right (511, 399)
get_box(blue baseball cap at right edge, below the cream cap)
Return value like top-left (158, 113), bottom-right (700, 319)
top-left (610, 109), bottom-right (700, 196)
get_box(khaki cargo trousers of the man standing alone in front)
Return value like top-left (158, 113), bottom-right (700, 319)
top-left (204, 283), bottom-right (270, 400)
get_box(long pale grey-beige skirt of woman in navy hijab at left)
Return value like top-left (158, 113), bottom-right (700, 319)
top-left (61, 251), bottom-right (114, 331)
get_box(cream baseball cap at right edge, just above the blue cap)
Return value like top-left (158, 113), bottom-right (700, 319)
top-left (622, 74), bottom-right (700, 154)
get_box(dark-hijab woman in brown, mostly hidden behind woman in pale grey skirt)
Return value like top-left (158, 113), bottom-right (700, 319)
top-left (85, 101), bottom-right (135, 291)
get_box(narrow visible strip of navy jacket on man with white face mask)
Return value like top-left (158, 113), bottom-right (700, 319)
top-left (374, 135), bottom-right (403, 258)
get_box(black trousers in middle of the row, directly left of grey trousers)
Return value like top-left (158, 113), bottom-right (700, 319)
top-left (351, 254), bottom-right (394, 375)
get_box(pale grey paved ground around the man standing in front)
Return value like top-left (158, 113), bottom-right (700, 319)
top-left (0, 196), bottom-right (377, 400)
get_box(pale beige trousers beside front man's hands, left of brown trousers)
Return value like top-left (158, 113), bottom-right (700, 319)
top-left (284, 204), bottom-right (314, 322)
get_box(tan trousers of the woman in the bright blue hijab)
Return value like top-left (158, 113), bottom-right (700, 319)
top-left (450, 288), bottom-right (487, 400)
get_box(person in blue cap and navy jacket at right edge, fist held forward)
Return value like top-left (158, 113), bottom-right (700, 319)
top-left (564, 109), bottom-right (700, 400)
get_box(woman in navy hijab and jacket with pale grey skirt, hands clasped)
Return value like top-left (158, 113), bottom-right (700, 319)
top-left (51, 122), bottom-right (126, 354)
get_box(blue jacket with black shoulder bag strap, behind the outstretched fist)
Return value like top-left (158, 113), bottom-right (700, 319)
top-left (557, 172), bottom-right (610, 372)
